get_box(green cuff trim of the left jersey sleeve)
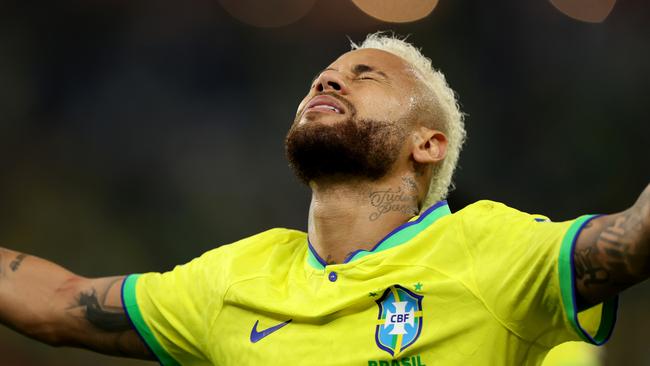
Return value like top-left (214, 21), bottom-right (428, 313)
top-left (122, 274), bottom-right (180, 366)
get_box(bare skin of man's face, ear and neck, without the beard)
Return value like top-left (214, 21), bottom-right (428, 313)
top-left (295, 49), bottom-right (447, 263)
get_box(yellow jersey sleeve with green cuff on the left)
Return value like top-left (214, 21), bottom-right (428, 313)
top-left (122, 248), bottom-right (226, 366)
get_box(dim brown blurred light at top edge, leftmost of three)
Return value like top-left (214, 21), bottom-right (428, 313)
top-left (219, 0), bottom-right (316, 28)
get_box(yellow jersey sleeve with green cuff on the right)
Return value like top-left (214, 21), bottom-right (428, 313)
top-left (461, 201), bottom-right (618, 347)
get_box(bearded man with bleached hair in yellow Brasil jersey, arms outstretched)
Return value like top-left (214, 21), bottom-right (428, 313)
top-left (0, 34), bottom-right (650, 366)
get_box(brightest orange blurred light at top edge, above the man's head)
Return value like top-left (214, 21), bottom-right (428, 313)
top-left (352, 0), bottom-right (438, 23)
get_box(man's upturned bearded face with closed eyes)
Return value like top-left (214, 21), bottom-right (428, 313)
top-left (286, 49), bottom-right (419, 183)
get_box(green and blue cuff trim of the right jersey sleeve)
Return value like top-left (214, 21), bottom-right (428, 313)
top-left (558, 215), bottom-right (618, 345)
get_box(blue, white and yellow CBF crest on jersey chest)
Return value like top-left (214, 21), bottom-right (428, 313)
top-left (375, 285), bottom-right (423, 357)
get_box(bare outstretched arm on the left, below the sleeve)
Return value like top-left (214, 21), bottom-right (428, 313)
top-left (0, 248), bottom-right (154, 360)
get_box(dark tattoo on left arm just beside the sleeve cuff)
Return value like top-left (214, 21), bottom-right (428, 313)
top-left (70, 279), bottom-right (132, 332)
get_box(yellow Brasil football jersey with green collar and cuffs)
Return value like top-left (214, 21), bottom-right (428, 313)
top-left (122, 201), bottom-right (618, 366)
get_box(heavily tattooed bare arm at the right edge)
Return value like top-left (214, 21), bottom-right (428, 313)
top-left (573, 185), bottom-right (650, 310)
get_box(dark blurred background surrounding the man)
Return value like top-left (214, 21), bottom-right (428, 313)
top-left (0, 0), bottom-right (650, 366)
